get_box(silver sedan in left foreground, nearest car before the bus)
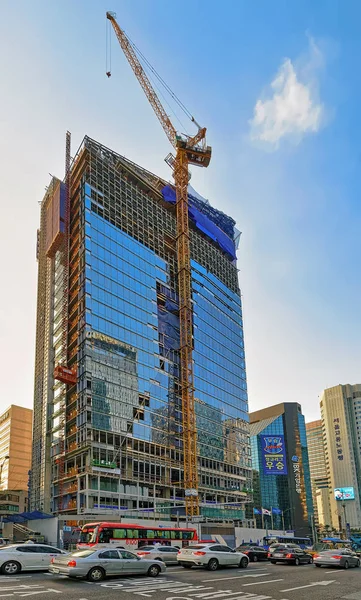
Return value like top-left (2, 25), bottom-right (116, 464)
top-left (49, 548), bottom-right (166, 581)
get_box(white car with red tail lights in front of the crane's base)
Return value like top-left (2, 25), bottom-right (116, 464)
top-left (178, 544), bottom-right (249, 571)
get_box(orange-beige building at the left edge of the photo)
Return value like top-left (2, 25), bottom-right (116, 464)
top-left (0, 404), bottom-right (33, 494)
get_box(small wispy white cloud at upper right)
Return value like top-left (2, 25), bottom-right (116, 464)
top-left (250, 39), bottom-right (324, 149)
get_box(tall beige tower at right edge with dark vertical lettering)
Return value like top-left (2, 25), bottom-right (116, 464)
top-left (320, 384), bottom-right (361, 529)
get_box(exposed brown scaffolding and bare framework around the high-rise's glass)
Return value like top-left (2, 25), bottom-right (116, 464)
top-left (33, 137), bottom-right (250, 513)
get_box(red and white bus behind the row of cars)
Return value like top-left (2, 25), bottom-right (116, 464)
top-left (77, 522), bottom-right (198, 550)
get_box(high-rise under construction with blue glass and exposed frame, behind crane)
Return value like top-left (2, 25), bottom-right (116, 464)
top-left (31, 137), bottom-right (252, 519)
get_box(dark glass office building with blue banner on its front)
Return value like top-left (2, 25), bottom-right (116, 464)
top-left (250, 402), bottom-right (313, 536)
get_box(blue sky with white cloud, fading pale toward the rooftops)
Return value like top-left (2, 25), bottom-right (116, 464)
top-left (0, 0), bottom-right (361, 419)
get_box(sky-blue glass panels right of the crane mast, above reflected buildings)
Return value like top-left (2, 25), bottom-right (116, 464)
top-left (192, 261), bottom-right (248, 422)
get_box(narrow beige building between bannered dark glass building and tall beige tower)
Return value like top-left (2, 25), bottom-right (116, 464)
top-left (306, 419), bottom-right (331, 526)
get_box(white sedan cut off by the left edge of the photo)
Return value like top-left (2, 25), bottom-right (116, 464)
top-left (0, 543), bottom-right (67, 575)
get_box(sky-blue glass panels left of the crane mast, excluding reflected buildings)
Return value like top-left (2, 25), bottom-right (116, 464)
top-left (85, 184), bottom-right (168, 441)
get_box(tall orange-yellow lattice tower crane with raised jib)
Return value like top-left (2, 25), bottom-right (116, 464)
top-left (106, 12), bottom-right (212, 517)
